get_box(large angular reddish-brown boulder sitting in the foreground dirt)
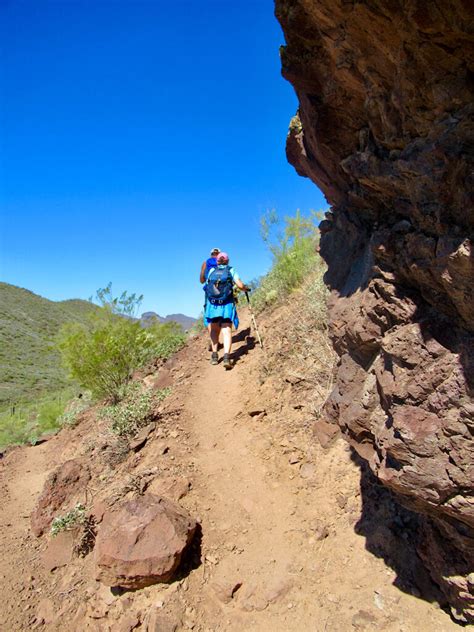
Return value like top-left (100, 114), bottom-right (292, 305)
top-left (95, 494), bottom-right (197, 589)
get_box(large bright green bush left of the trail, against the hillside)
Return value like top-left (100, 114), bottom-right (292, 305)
top-left (58, 284), bottom-right (185, 402)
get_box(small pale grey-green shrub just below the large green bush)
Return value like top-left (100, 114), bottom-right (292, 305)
top-left (100, 382), bottom-right (170, 436)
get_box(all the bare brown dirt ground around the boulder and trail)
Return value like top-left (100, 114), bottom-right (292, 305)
top-left (0, 313), bottom-right (459, 632)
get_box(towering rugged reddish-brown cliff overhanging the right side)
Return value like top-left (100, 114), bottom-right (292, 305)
top-left (276, 0), bottom-right (474, 622)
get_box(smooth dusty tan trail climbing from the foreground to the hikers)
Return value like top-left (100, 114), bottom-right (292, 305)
top-left (172, 317), bottom-right (458, 632)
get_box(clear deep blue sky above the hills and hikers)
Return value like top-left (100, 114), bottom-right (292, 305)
top-left (0, 0), bottom-right (326, 316)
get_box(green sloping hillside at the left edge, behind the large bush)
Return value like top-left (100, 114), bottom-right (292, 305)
top-left (0, 283), bottom-right (97, 410)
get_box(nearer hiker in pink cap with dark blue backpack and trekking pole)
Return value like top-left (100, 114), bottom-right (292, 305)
top-left (204, 252), bottom-right (249, 370)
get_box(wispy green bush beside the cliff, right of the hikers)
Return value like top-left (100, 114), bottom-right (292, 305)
top-left (252, 210), bottom-right (323, 312)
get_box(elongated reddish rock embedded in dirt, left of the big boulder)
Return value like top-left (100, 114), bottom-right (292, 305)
top-left (31, 459), bottom-right (91, 536)
